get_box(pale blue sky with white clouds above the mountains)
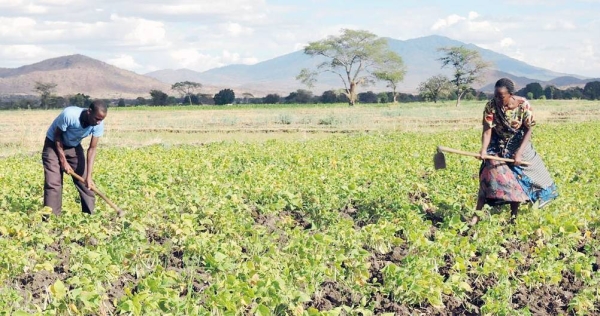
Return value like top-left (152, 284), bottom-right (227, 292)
top-left (0, 0), bottom-right (600, 77)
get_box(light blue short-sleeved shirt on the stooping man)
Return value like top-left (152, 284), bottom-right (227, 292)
top-left (46, 106), bottom-right (104, 147)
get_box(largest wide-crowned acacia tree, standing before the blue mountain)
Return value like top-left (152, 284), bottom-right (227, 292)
top-left (296, 29), bottom-right (400, 105)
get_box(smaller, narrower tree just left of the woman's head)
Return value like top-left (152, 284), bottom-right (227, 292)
top-left (438, 46), bottom-right (491, 106)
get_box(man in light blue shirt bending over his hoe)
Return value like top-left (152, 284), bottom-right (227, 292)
top-left (42, 100), bottom-right (107, 215)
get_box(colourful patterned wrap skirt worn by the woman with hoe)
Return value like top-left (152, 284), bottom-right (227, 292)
top-left (479, 135), bottom-right (558, 208)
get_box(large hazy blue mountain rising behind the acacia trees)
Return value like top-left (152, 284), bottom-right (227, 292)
top-left (146, 35), bottom-right (584, 93)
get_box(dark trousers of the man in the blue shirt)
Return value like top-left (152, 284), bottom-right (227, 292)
top-left (42, 138), bottom-right (96, 215)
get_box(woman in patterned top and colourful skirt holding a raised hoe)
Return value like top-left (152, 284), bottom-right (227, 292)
top-left (470, 78), bottom-right (558, 225)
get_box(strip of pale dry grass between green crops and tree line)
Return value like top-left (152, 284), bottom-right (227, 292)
top-left (0, 100), bottom-right (600, 157)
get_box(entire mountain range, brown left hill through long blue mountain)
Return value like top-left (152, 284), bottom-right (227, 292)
top-left (0, 35), bottom-right (599, 98)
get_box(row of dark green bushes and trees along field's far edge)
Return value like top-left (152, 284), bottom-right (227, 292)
top-left (0, 81), bottom-right (600, 110)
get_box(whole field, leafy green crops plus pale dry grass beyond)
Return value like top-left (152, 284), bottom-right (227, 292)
top-left (0, 102), bottom-right (600, 315)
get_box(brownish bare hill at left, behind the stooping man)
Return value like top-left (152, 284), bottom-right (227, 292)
top-left (0, 55), bottom-right (170, 98)
